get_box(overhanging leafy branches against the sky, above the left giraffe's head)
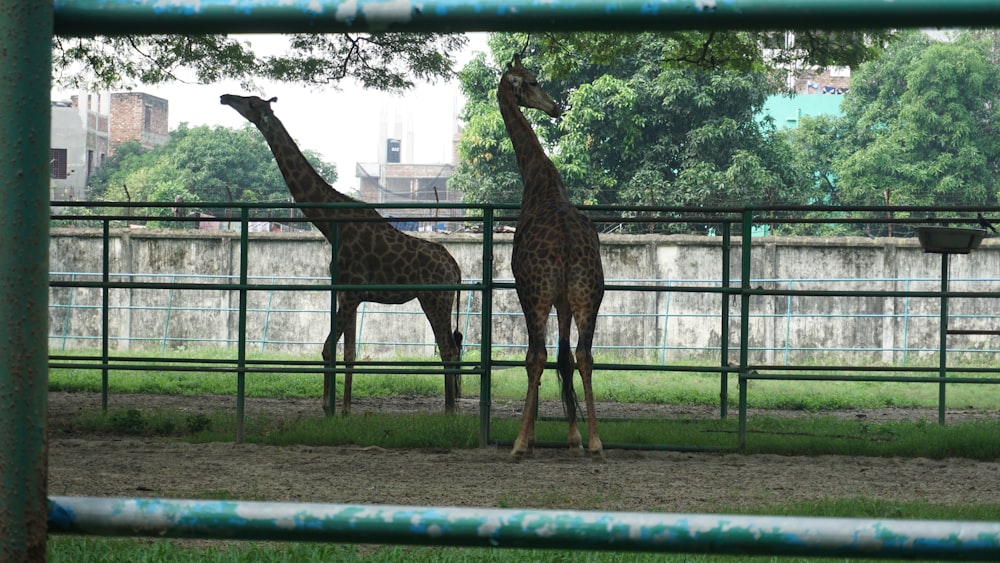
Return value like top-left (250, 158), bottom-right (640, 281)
top-left (52, 33), bottom-right (467, 91)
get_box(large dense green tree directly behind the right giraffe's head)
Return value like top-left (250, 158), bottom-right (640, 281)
top-left (450, 33), bottom-right (824, 232)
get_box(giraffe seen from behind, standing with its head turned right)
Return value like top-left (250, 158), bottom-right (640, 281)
top-left (497, 56), bottom-right (604, 461)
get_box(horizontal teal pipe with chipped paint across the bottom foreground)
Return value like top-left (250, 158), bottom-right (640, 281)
top-left (49, 497), bottom-right (1000, 560)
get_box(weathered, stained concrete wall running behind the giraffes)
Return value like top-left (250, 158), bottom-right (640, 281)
top-left (49, 229), bottom-right (1000, 365)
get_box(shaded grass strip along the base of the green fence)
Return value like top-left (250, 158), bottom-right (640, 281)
top-left (58, 409), bottom-right (1000, 460)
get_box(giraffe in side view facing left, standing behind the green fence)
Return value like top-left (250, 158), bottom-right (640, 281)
top-left (220, 94), bottom-right (462, 415)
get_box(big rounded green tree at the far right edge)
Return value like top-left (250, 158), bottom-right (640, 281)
top-left (833, 33), bottom-right (1000, 234)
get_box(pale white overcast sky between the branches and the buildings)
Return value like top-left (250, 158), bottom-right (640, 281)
top-left (54, 33), bottom-right (487, 197)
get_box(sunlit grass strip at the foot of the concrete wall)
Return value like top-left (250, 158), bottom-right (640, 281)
top-left (49, 348), bottom-right (1000, 411)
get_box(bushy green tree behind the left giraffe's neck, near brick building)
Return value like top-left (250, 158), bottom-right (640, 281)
top-left (88, 123), bottom-right (337, 225)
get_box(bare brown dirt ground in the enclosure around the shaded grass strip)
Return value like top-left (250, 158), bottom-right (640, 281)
top-left (48, 393), bottom-right (1000, 512)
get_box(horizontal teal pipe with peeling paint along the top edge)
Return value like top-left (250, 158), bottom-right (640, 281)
top-left (55, 0), bottom-right (1000, 35)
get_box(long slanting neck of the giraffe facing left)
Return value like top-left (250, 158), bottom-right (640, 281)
top-left (255, 115), bottom-right (356, 239)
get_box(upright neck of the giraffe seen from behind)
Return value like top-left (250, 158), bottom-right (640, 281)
top-left (497, 77), bottom-right (568, 210)
